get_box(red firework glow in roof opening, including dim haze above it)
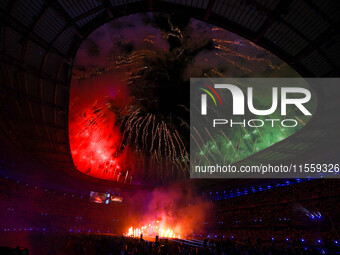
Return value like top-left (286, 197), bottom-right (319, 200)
top-left (69, 70), bottom-right (133, 182)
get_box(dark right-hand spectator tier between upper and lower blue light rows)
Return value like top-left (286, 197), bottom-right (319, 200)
top-left (214, 179), bottom-right (340, 228)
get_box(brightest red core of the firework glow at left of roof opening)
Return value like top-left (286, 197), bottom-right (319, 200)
top-left (70, 105), bottom-right (120, 180)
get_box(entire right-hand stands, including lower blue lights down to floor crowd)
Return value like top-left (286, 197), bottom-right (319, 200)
top-left (196, 179), bottom-right (340, 253)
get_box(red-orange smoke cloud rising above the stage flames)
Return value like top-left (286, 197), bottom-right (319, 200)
top-left (126, 183), bottom-right (211, 238)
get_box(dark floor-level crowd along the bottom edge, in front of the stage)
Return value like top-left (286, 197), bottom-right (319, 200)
top-left (3, 234), bottom-right (339, 255)
